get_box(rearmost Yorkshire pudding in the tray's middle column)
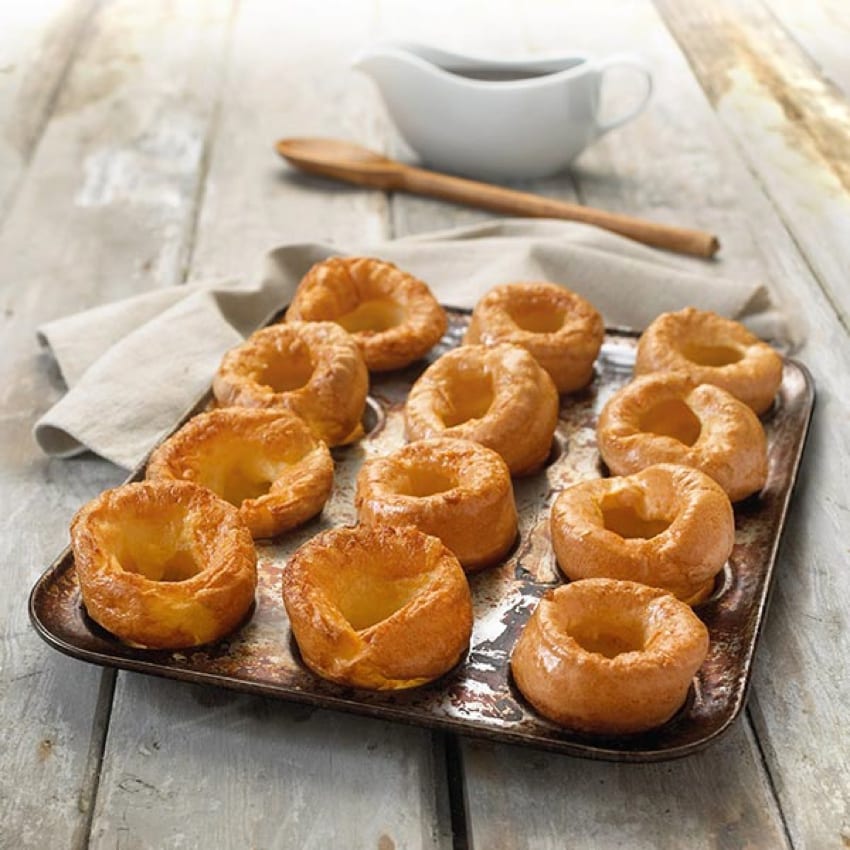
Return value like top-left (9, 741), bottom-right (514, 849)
top-left (463, 282), bottom-right (605, 393)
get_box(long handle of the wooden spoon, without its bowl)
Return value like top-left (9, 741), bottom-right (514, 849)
top-left (395, 165), bottom-right (720, 257)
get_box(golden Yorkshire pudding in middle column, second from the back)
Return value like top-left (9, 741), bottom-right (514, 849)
top-left (404, 343), bottom-right (558, 475)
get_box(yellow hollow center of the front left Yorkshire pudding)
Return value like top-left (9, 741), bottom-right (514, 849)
top-left (113, 517), bottom-right (203, 582)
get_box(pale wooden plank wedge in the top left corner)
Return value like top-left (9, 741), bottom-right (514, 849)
top-left (0, 0), bottom-right (97, 221)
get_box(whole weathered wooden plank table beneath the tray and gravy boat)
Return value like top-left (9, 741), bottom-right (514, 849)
top-left (0, 0), bottom-right (850, 850)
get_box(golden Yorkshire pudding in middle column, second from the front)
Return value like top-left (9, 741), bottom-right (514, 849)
top-left (355, 437), bottom-right (517, 571)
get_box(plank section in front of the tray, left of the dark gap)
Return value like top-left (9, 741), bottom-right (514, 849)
top-left (90, 673), bottom-right (450, 850)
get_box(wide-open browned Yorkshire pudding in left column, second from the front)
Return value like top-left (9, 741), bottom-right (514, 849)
top-left (147, 407), bottom-right (334, 537)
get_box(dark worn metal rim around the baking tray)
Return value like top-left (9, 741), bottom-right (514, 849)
top-left (28, 320), bottom-right (816, 763)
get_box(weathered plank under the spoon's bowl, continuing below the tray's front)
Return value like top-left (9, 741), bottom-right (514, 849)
top-left (92, 2), bottom-right (451, 848)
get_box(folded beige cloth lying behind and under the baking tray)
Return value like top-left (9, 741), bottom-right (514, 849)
top-left (34, 219), bottom-right (800, 469)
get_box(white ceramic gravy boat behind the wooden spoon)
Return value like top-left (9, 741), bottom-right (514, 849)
top-left (354, 42), bottom-right (652, 179)
